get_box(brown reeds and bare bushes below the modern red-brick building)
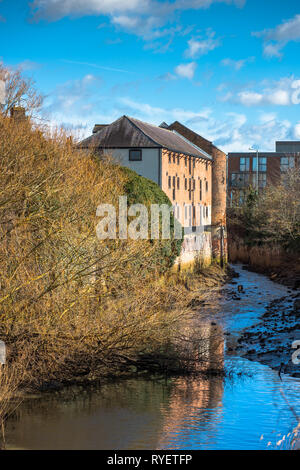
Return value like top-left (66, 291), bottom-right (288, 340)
top-left (228, 167), bottom-right (300, 282)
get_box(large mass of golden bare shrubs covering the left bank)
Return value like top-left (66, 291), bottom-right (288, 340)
top-left (0, 113), bottom-right (225, 444)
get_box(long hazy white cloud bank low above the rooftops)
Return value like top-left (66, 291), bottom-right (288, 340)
top-left (41, 75), bottom-right (294, 152)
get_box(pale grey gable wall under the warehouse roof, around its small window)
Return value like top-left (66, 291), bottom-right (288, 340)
top-left (104, 148), bottom-right (160, 185)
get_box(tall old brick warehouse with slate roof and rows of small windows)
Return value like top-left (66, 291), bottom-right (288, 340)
top-left (80, 116), bottom-right (227, 264)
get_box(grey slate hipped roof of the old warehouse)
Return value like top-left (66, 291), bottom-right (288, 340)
top-left (79, 116), bottom-right (211, 160)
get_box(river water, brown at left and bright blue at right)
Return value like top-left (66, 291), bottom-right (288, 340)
top-left (6, 265), bottom-right (300, 450)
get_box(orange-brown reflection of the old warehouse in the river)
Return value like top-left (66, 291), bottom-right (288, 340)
top-left (157, 324), bottom-right (224, 449)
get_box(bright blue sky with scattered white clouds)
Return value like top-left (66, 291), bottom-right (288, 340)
top-left (0, 0), bottom-right (300, 152)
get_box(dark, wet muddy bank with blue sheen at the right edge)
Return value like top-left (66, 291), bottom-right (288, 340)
top-left (234, 291), bottom-right (300, 377)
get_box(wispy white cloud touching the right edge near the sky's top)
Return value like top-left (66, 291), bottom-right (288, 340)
top-left (253, 14), bottom-right (300, 58)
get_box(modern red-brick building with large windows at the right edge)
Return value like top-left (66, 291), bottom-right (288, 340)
top-left (228, 141), bottom-right (300, 205)
